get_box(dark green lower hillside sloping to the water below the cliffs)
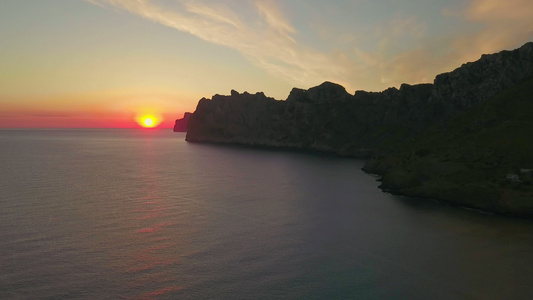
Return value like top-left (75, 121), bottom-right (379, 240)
top-left (364, 78), bottom-right (533, 216)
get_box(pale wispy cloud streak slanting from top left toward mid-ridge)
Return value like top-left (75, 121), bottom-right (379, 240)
top-left (86, 0), bottom-right (348, 89)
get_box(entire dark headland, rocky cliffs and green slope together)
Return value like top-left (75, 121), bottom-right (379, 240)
top-left (180, 43), bottom-right (533, 216)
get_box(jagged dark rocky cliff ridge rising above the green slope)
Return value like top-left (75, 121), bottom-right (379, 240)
top-left (186, 43), bottom-right (533, 156)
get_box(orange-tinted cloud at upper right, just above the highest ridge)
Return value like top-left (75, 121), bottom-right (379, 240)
top-left (350, 0), bottom-right (533, 86)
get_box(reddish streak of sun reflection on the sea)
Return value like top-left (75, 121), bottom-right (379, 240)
top-left (124, 137), bottom-right (183, 299)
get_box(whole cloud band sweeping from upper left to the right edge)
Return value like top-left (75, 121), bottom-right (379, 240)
top-left (85, 0), bottom-right (533, 94)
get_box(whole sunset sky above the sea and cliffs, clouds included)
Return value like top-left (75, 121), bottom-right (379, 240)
top-left (0, 0), bottom-right (533, 128)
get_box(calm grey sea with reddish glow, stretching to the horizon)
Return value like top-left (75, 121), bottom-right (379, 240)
top-left (0, 130), bottom-right (533, 299)
